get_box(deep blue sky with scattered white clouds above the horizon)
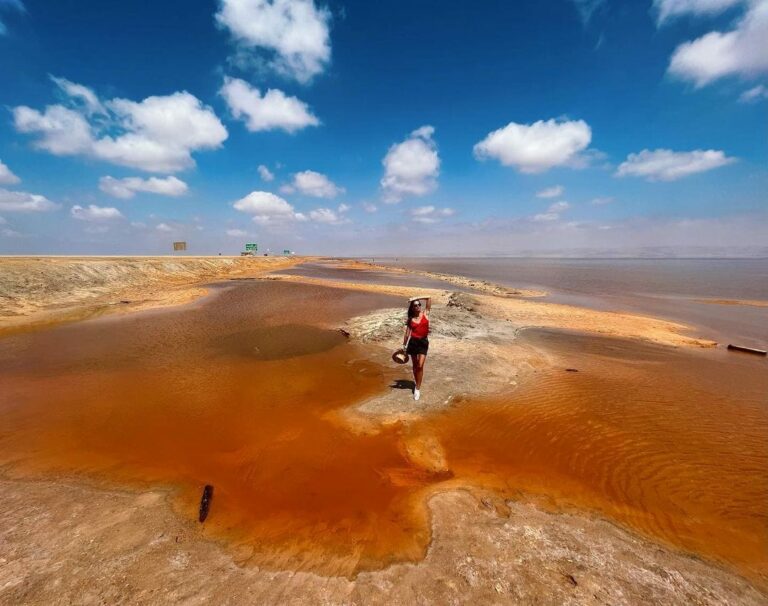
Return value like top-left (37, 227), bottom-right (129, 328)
top-left (0, 0), bottom-right (768, 255)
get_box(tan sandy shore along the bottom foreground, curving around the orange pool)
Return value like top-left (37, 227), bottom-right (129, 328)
top-left (0, 481), bottom-right (766, 606)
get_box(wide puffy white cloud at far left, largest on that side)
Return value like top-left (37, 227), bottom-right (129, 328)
top-left (13, 81), bottom-right (227, 173)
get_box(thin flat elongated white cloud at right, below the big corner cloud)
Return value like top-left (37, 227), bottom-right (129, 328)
top-left (616, 149), bottom-right (736, 181)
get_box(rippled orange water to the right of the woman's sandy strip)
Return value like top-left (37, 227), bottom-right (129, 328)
top-left (429, 332), bottom-right (768, 576)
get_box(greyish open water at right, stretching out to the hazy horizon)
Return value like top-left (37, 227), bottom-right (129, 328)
top-left (376, 257), bottom-right (768, 349)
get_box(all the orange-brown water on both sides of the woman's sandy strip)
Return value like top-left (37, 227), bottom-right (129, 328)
top-left (0, 282), bottom-right (768, 576)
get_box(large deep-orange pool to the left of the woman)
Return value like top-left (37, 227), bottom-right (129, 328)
top-left (0, 282), bottom-right (436, 574)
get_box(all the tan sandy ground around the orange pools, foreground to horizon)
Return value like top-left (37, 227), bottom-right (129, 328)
top-left (0, 258), bottom-right (768, 604)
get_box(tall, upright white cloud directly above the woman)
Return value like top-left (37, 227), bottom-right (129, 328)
top-left (381, 126), bottom-right (440, 203)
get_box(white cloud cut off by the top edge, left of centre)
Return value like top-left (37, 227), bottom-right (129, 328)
top-left (216, 0), bottom-right (331, 82)
